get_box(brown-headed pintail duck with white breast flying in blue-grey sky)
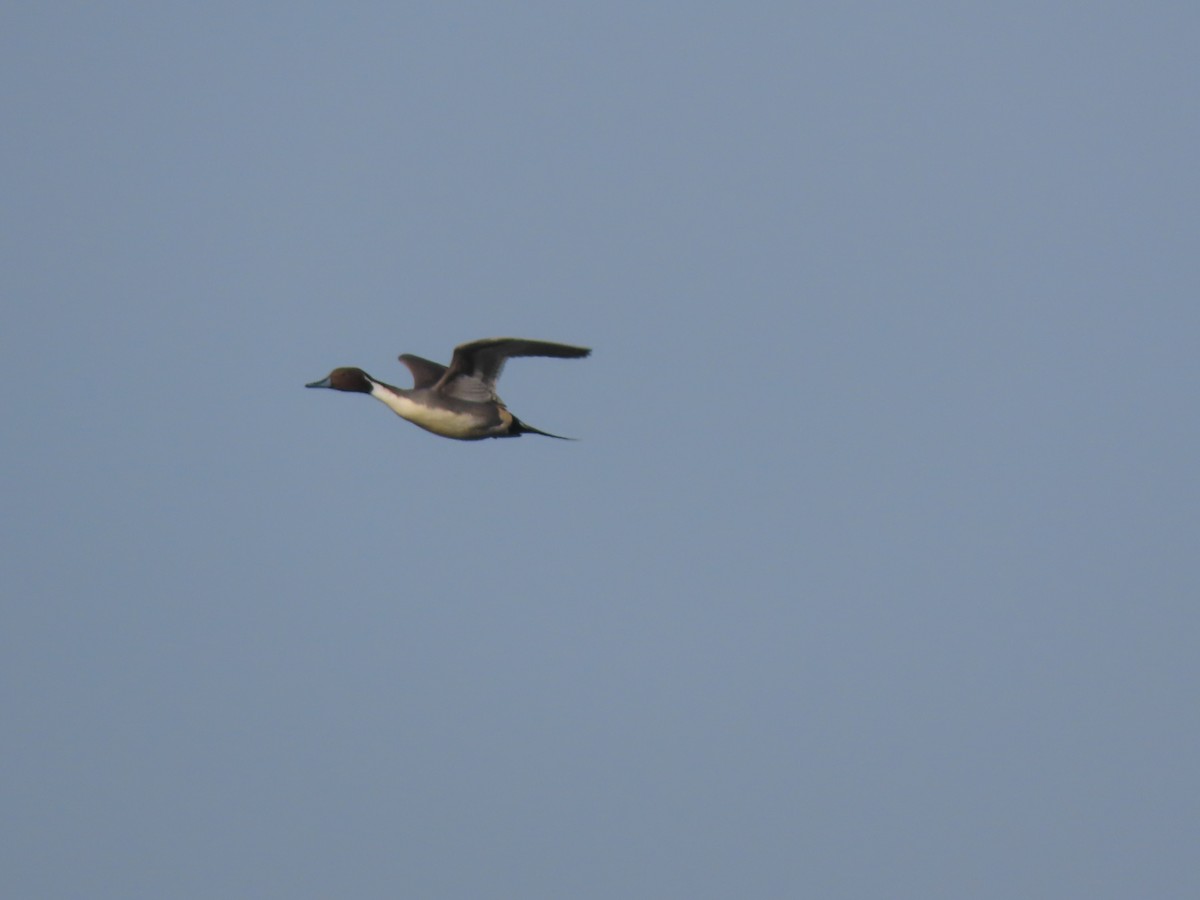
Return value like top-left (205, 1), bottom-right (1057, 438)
top-left (305, 337), bottom-right (592, 440)
